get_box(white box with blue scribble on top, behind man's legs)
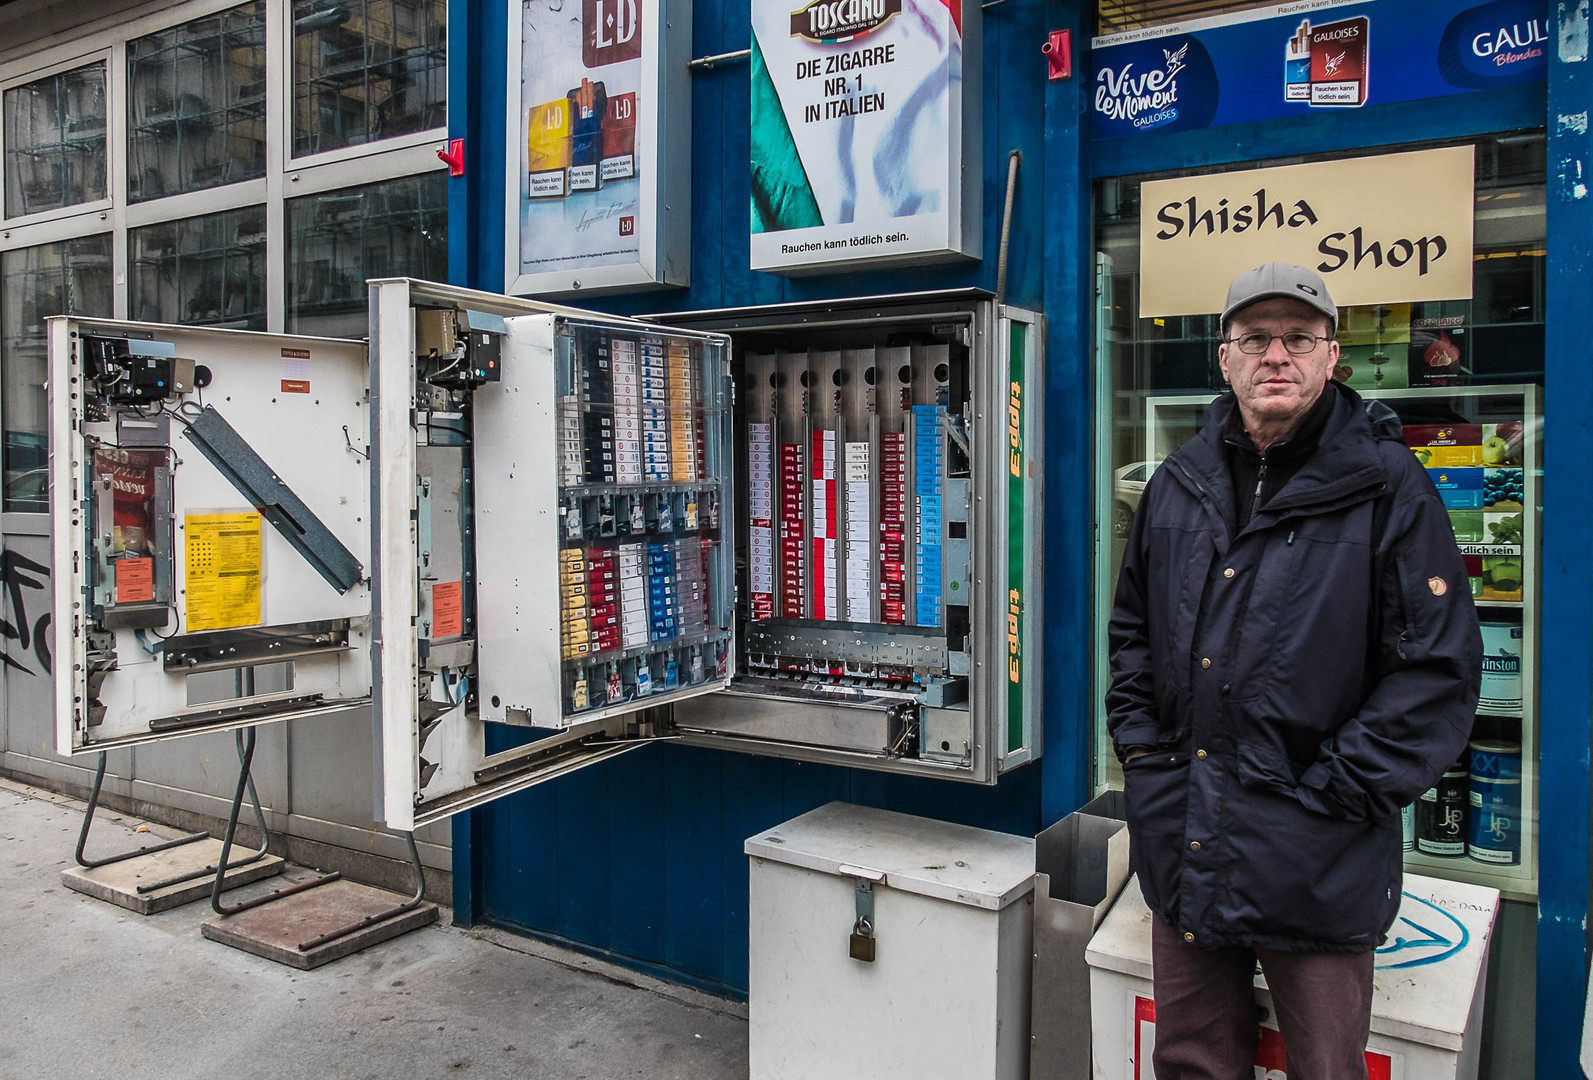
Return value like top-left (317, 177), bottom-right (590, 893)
top-left (1085, 875), bottom-right (1499, 1080)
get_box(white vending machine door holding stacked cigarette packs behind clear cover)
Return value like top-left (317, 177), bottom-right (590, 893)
top-left (370, 279), bottom-right (734, 828)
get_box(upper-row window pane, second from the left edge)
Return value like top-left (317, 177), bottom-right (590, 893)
top-left (127, 0), bottom-right (266, 202)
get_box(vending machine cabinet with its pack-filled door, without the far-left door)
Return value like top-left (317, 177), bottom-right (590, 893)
top-left (370, 279), bottom-right (1042, 828)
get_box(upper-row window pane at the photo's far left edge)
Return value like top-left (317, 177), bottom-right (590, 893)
top-left (5, 64), bottom-right (105, 218)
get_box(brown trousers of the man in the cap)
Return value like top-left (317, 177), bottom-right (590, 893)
top-left (1150, 918), bottom-right (1372, 1080)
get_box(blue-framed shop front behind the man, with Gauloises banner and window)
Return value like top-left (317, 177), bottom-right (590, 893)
top-left (1086, 0), bottom-right (1590, 1075)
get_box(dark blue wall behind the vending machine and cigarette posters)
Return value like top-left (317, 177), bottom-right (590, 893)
top-left (449, 0), bottom-right (1064, 994)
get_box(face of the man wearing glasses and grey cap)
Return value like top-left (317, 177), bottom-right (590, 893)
top-left (1217, 298), bottom-right (1338, 430)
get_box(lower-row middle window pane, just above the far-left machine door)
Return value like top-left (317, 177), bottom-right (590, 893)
top-left (127, 205), bottom-right (266, 330)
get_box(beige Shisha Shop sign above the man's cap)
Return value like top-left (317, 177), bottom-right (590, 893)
top-left (1139, 147), bottom-right (1475, 319)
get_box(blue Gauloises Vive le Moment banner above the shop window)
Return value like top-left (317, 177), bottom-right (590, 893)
top-left (1091, 0), bottom-right (1550, 139)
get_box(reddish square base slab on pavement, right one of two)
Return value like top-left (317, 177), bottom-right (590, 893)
top-left (199, 881), bottom-right (436, 972)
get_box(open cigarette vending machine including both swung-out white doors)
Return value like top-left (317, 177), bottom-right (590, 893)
top-left (40, 279), bottom-right (1042, 828)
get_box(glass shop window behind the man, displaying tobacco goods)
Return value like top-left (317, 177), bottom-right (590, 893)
top-left (1094, 131), bottom-right (1547, 898)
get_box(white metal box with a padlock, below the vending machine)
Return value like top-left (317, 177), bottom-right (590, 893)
top-left (746, 803), bottom-right (1034, 1080)
